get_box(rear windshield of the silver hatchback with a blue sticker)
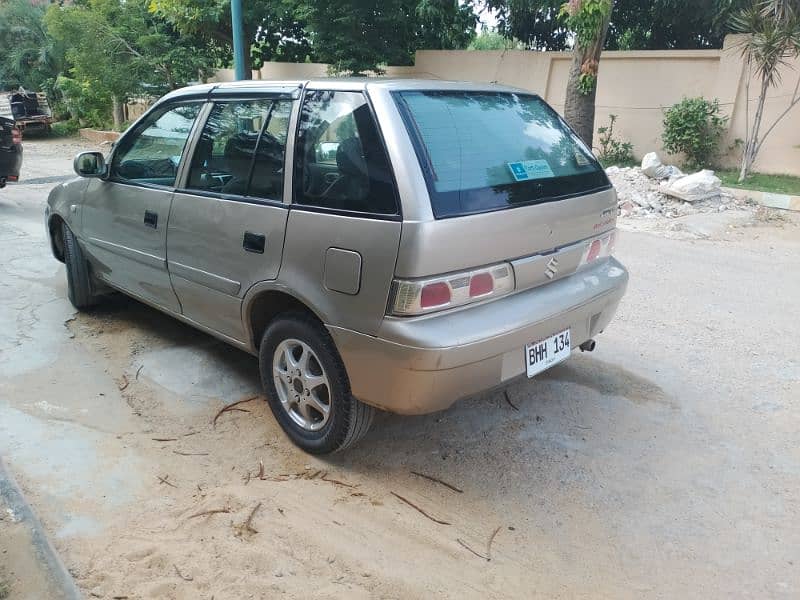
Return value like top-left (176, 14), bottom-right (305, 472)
top-left (395, 91), bottom-right (610, 218)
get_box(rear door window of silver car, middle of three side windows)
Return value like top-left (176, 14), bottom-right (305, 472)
top-left (187, 99), bottom-right (292, 200)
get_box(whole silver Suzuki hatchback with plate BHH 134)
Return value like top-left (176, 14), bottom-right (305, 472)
top-left (46, 79), bottom-right (628, 453)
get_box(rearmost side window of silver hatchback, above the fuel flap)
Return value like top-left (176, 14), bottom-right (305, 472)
top-left (294, 91), bottom-right (398, 215)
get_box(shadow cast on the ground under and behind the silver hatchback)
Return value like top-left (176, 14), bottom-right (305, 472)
top-left (75, 294), bottom-right (675, 491)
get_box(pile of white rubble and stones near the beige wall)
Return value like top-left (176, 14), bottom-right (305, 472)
top-left (606, 152), bottom-right (739, 219)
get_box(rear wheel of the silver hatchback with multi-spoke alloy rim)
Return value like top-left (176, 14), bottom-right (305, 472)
top-left (258, 313), bottom-right (375, 454)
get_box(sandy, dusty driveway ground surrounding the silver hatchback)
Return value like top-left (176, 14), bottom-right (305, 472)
top-left (0, 137), bottom-right (800, 600)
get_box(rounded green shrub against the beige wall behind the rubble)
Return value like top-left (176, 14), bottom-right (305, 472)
top-left (662, 98), bottom-right (728, 169)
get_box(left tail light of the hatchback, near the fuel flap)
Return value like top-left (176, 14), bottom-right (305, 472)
top-left (389, 263), bottom-right (514, 316)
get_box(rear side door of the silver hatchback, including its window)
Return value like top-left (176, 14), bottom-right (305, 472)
top-left (167, 92), bottom-right (294, 342)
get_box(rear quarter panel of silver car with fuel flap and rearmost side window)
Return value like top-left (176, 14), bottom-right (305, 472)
top-left (280, 89), bottom-right (402, 335)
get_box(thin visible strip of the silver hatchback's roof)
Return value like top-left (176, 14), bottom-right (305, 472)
top-left (161, 77), bottom-right (531, 102)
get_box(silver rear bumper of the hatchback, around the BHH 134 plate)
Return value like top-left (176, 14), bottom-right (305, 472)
top-left (328, 258), bottom-right (628, 414)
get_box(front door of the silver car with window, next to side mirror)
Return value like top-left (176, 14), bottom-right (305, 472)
top-left (81, 102), bottom-right (202, 313)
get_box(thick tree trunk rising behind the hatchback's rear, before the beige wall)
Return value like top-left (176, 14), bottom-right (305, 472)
top-left (564, 2), bottom-right (614, 148)
